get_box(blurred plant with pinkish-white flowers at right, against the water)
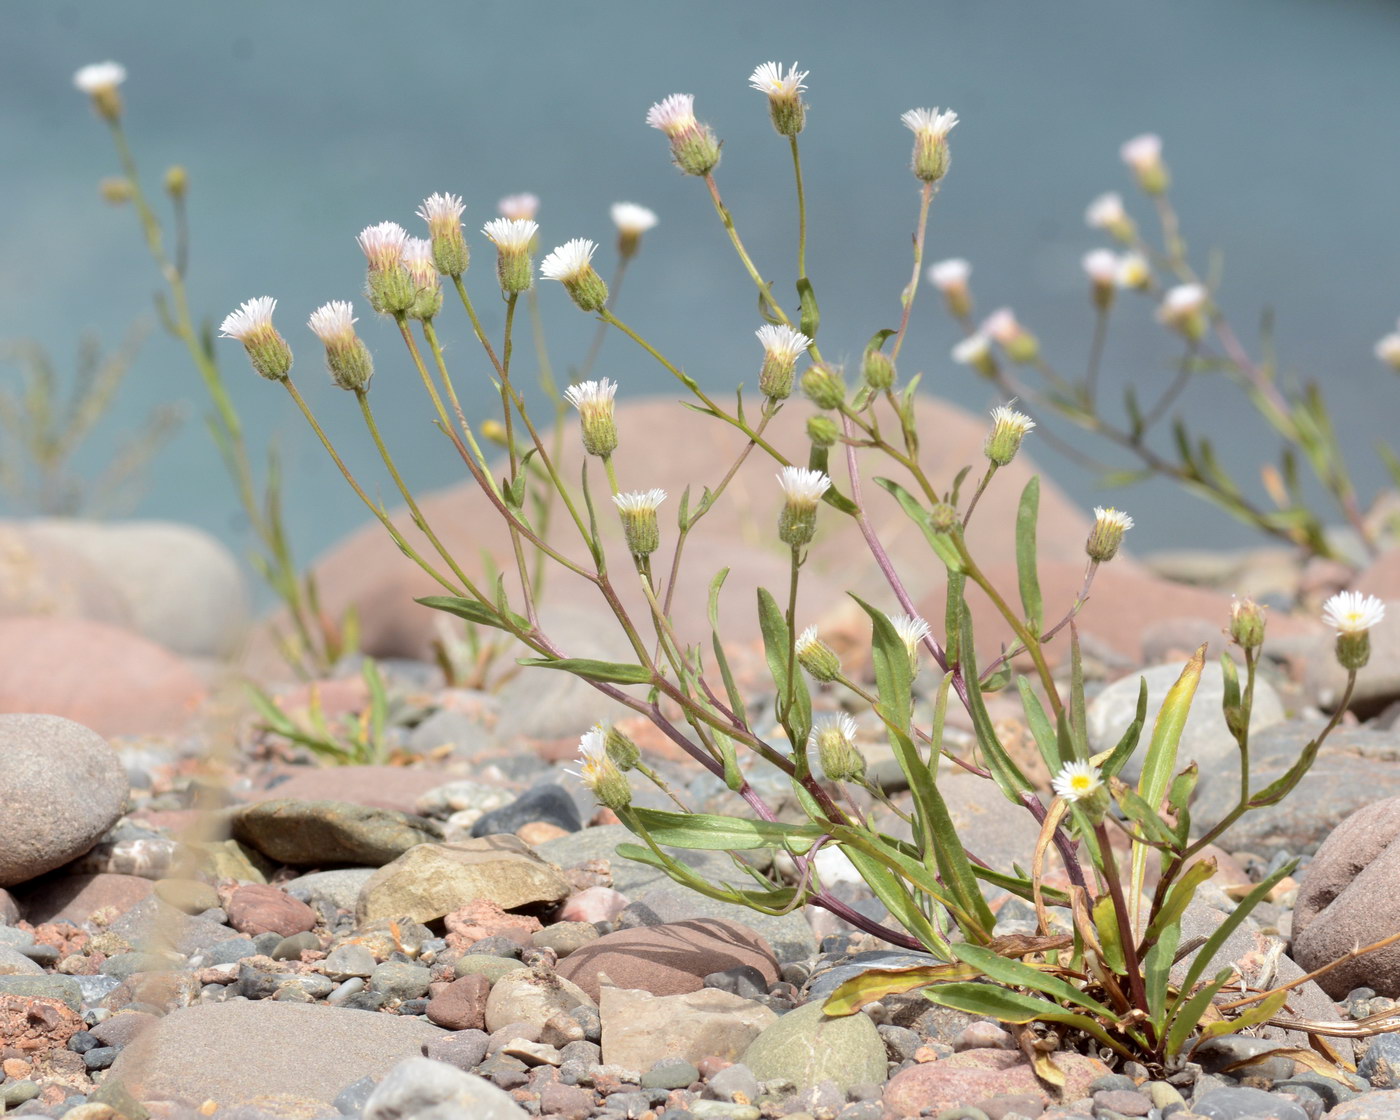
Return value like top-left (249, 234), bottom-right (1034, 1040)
top-left (928, 133), bottom-right (1400, 563)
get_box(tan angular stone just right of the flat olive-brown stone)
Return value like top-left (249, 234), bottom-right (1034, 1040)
top-left (356, 836), bottom-right (570, 924)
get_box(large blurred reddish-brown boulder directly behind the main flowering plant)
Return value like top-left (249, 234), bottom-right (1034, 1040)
top-left (298, 398), bottom-right (1089, 658)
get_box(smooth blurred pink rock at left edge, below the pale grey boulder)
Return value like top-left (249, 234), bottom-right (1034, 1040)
top-left (0, 617), bottom-right (204, 735)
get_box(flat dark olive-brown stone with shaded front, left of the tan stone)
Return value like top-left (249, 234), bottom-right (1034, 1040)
top-left (232, 798), bottom-right (440, 867)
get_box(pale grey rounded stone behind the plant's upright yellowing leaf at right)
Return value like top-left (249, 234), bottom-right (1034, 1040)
top-left (1086, 661), bottom-right (1284, 787)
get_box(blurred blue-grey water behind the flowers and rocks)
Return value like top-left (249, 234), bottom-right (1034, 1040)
top-left (0, 0), bottom-right (1400, 599)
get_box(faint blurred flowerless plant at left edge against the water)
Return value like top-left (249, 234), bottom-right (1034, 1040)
top-left (0, 326), bottom-right (181, 517)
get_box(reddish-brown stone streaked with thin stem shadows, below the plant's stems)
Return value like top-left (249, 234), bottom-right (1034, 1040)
top-left (559, 918), bottom-right (778, 1000)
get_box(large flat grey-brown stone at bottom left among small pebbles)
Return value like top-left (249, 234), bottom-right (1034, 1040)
top-left (108, 1000), bottom-right (445, 1107)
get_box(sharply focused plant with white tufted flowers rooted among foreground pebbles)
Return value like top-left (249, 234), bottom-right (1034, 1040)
top-left (212, 63), bottom-right (1383, 1084)
